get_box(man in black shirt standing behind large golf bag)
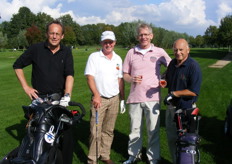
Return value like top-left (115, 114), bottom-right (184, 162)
top-left (13, 20), bottom-right (74, 164)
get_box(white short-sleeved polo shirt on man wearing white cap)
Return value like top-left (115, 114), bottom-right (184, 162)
top-left (85, 51), bottom-right (123, 98)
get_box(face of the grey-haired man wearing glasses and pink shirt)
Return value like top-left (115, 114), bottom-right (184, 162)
top-left (137, 28), bottom-right (153, 49)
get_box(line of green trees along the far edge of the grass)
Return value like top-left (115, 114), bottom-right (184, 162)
top-left (0, 7), bottom-right (232, 49)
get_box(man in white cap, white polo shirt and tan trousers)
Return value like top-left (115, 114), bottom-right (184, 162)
top-left (85, 31), bottom-right (125, 164)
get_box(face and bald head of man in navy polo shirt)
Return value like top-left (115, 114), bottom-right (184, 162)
top-left (173, 40), bottom-right (190, 63)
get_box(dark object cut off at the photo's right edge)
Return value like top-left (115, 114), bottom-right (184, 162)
top-left (224, 100), bottom-right (232, 136)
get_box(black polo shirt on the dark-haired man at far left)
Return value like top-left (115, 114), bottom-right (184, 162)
top-left (13, 42), bottom-right (74, 94)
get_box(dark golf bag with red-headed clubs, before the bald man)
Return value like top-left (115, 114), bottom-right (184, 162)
top-left (175, 108), bottom-right (200, 164)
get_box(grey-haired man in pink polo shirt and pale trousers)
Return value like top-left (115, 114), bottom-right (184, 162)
top-left (123, 24), bottom-right (171, 164)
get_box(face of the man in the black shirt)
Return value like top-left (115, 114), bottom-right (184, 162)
top-left (46, 24), bottom-right (64, 47)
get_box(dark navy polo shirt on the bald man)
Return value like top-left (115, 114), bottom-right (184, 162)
top-left (166, 57), bottom-right (202, 109)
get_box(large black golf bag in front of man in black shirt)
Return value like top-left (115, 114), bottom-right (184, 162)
top-left (0, 95), bottom-right (85, 164)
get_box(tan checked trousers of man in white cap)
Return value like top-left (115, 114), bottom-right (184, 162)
top-left (88, 95), bottom-right (119, 164)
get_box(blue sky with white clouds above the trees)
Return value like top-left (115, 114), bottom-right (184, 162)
top-left (0, 0), bottom-right (232, 37)
